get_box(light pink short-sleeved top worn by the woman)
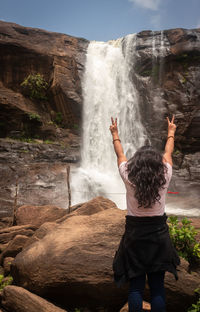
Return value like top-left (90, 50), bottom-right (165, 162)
top-left (119, 161), bottom-right (172, 217)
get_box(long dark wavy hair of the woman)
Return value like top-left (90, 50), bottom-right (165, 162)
top-left (127, 146), bottom-right (167, 208)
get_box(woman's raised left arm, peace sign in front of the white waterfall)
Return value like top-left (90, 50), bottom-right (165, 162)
top-left (110, 118), bottom-right (127, 166)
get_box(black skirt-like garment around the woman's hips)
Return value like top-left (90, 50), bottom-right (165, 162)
top-left (113, 214), bottom-right (180, 287)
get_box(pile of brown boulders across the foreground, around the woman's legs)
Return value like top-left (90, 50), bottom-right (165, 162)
top-left (0, 197), bottom-right (200, 312)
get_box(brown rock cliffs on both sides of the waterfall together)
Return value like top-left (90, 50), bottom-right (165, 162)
top-left (0, 22), bottom-right (200, 217)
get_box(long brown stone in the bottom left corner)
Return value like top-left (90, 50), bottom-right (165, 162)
top-left (2, 286), bottom-right (66, 312)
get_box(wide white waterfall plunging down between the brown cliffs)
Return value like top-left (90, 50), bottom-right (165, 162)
top-left (71, 35), bottom-right (146, 209)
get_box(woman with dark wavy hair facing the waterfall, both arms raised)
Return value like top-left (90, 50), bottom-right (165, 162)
top-left (110, 116), bottom-right (180, 312)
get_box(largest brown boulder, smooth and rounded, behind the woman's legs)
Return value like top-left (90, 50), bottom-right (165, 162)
top-left (11, 199), bottom-right (199, 312)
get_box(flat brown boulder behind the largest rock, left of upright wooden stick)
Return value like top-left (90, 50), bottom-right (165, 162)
top-left (16, 205), bottom-right (68, 227)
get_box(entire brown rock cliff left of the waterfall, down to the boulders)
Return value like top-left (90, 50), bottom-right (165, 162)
top-left (0, 22), bottom-right (88, 216)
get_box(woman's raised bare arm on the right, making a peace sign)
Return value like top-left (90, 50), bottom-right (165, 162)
top-left (163, 115), bottom-right (176, 166)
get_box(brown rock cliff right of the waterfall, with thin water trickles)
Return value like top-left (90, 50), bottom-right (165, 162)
top-left (125, 29), bottom-right (200, 208)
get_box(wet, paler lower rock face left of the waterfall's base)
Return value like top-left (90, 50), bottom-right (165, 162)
top-left (0, 139), bottom-right (80, 217)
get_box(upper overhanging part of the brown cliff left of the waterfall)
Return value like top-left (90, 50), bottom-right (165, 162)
top-left (0, 22), bottom-right (88, 137)
